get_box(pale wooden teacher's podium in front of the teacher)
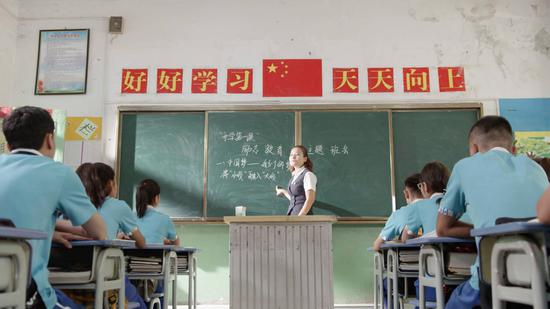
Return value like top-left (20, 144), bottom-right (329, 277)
top-left (224, 216), bottom-right (336, 309)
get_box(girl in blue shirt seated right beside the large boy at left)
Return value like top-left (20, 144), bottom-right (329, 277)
top-left (76, 162), bottom-right (146, 309)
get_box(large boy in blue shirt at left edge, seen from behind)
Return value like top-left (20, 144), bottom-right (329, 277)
top-left (0, 106), bottom-right (106, 308)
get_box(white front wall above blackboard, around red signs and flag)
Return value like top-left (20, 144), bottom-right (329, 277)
top-left (10, 0), bottom-right (550, 164)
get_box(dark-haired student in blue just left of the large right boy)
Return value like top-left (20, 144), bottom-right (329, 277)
top-left (405, 161), bottom-right (450, 236)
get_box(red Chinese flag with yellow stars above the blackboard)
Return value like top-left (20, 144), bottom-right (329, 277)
top-left (263, 59), bottom-right (323, 97)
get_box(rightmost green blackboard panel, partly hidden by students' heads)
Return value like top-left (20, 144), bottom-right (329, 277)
top-left (392, 110), bottom-right (479, 207)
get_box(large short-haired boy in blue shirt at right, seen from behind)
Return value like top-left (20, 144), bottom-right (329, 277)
top-left (437, 116), bottom-right (548, 308)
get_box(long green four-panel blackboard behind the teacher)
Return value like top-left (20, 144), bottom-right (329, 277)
top-left (117, 108), bottom-right (479, 219)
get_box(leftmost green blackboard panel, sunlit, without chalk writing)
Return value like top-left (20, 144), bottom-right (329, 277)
top-left (119, 113), bottom-right (204, 217)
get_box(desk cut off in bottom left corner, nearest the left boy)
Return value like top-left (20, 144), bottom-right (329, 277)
top-left (0, 226), bottom-right (48, 309)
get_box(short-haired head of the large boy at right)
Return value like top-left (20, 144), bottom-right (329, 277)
top-left (468, 116), bottom-right (514, 155)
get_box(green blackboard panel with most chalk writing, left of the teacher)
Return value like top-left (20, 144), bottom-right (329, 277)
top-left (207, 111), bottom-right (295, 217)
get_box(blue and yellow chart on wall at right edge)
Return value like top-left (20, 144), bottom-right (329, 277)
top-left (499, 98), bottom-right (550, 157)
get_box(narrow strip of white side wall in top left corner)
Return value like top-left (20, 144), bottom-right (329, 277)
top-left (0, 0), bottom-right (17, 106)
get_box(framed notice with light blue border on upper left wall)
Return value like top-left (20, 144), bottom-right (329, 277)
top-left (34, 29), bottom-right (90, 95)
